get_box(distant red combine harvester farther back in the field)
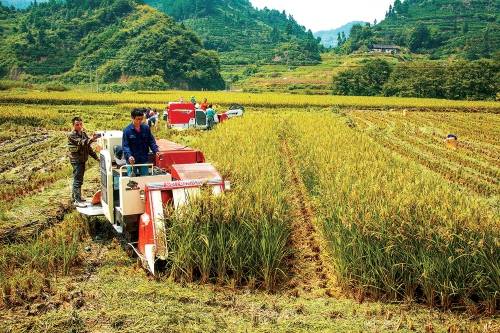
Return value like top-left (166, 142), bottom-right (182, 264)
top-left (168, 102), bottom-right (244, 130)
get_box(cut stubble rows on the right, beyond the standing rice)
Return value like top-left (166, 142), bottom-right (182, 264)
top-left (349, 112), bottom-right (500, 197)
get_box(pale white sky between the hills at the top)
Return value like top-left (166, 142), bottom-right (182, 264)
top-left (250, 0), bottom-right (394, 32)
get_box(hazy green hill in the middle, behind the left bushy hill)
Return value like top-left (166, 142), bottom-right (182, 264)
top-left (145, 0), bottom-right (321, 65)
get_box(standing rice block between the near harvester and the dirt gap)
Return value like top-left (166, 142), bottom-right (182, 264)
top-left (154, 114), bottom-right (290, 289)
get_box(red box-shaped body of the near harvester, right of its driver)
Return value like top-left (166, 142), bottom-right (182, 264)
top-left (156, 140), bottom-right (205, 172)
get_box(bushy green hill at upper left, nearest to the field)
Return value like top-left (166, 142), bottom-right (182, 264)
top-left (0, 0), bottom-right (224, 89)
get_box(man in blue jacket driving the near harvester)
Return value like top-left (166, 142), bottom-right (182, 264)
top-left (122, 109), bottom-right (158, 176)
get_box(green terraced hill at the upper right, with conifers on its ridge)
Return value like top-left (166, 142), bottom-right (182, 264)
top-left (343, 0), bottom-right (500, 59)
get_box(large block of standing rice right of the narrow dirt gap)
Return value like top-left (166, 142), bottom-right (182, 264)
top-left (289, 113), bottom-right (500, 312)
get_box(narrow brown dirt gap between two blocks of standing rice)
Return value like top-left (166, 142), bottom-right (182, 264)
top-left (281, 139), bottom-right (335, 297)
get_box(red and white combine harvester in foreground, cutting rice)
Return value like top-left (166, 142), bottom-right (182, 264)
top-left (77, 131), bottom-right (230, 275)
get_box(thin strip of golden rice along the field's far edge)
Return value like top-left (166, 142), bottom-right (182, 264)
top-left (0, 91), bottom-right (500, 113)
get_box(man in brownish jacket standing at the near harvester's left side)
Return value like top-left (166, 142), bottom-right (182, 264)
top-left (68, 117), bottom-right (99, 207)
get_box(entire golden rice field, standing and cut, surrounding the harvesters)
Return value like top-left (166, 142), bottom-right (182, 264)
top-left (0, 92), bottom-right (500, 332)
